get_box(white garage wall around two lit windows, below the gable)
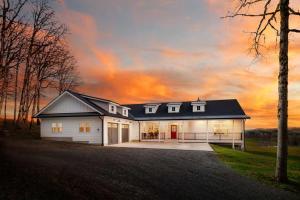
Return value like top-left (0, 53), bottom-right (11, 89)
top-left (41, 117), bottom-right (102, 144)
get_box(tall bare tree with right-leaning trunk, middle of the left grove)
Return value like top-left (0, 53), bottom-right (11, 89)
top-left (18, 0), bottom-right (67, 121)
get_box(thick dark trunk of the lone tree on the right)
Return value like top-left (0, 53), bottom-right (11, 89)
top-left (275, 0), bottom-right (289, 183)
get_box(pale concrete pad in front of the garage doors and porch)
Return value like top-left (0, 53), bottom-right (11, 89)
top-left (109, 142), bottom-right (213, 151)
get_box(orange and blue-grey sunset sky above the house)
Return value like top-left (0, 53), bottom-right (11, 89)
top-left (55, 0), bottom-right (300, 128)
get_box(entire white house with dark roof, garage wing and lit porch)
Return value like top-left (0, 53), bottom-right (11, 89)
top-left (35, 91), bottom-right (250, 147)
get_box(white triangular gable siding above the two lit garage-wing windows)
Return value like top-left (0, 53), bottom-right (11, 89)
top-left (43, 93), bottom-right (95, 114)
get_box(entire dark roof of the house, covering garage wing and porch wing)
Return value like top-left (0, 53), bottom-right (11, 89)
top-left (35, 90), bottom-right (250, 120)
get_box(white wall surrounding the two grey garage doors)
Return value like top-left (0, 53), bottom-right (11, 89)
top-left (103, 116), bottom-right (135, 145)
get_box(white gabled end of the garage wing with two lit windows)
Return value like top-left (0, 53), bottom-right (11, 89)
top-left (37, 92), bottom-right (103, 144)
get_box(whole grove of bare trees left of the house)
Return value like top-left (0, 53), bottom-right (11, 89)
top-left (0, 0), bottom-right (80, 126)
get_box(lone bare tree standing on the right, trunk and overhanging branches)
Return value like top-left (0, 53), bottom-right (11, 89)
top-left (224, 0), bottom-right (300, 182)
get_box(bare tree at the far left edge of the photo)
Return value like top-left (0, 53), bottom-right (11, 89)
top-left (0, 0), bottom-right (27, 124)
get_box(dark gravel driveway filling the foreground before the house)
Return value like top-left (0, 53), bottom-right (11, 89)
top-left (0, 139), bottom-right (297, 200)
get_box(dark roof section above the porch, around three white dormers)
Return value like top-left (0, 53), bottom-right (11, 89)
top-left (124, 99), bottom-right (249, 120)
